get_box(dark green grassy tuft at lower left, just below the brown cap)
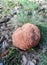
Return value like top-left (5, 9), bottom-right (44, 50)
top-left (3, 48), bottom-right (21, 65)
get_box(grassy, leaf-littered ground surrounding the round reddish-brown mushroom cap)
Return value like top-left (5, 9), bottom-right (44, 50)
top-left (0, 0), bottom-right (47, 65)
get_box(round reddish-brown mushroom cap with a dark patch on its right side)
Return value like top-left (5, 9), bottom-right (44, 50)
top-left (12, 23), bottom-right (40, 50)
